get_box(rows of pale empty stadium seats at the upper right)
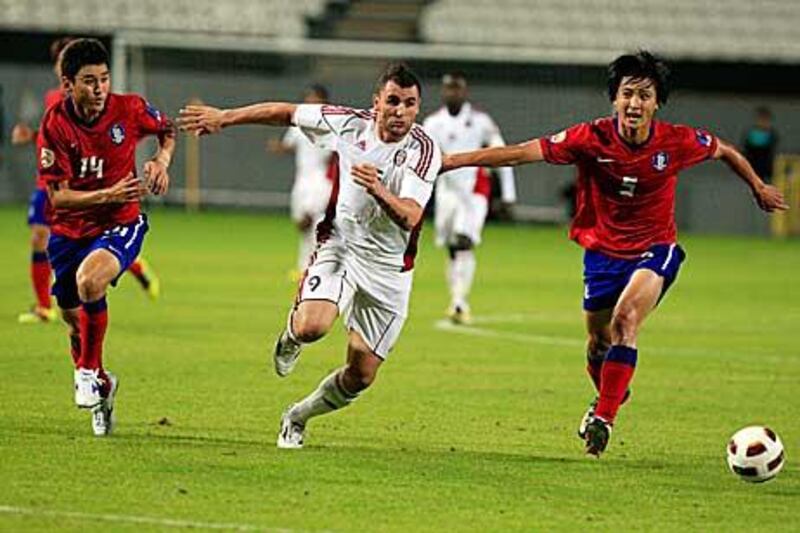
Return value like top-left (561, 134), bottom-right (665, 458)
top-left (420, 0), bottom-right (800, 61)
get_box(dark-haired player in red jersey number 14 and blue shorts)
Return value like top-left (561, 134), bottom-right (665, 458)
top-left (37, 39), bottom-right (175, 435)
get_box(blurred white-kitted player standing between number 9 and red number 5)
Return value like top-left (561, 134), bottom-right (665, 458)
top-left (424, 72), bottom-right (517, 324)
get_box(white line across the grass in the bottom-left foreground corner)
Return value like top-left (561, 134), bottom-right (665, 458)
top-left (0, 505), bottom-right (304, 533)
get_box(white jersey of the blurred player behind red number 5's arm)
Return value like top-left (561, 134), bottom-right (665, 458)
top-left (423, 102), bottom-right (517, 203)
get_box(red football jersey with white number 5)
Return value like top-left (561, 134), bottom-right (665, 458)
top-left (540, 117), bottom-right (717, 258)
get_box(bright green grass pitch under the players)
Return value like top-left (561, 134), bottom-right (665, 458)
top-left (0, 206), bottom-right (800, 531)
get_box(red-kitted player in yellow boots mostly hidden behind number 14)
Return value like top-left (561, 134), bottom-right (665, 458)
top-left (16, 37), bottom-right (160, 324)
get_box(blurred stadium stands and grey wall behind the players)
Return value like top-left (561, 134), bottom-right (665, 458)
top-left (0, 0), bottom-right (800, 235)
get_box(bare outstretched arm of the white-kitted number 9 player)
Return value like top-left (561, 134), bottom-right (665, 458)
top-left (178, 102), bottom-right (297, 135)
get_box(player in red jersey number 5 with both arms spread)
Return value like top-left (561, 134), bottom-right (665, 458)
top-left (442, 51), bottom-right (787, 456)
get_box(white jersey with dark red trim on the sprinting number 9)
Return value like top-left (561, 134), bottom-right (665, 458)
top-left (293, 104), bottom-right (442, 272)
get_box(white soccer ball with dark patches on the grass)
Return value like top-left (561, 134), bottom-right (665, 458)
top-left (728, 426), bottom-right (785, 483)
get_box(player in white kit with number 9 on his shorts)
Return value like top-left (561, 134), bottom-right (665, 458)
top-left (179, 64), bottom-right (441, 448)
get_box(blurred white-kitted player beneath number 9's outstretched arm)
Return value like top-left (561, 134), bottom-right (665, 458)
top-left (267, 84), bottom-right (333, 280)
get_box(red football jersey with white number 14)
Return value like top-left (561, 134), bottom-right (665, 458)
top-left (37, 94), bottom-right (172, 239)
